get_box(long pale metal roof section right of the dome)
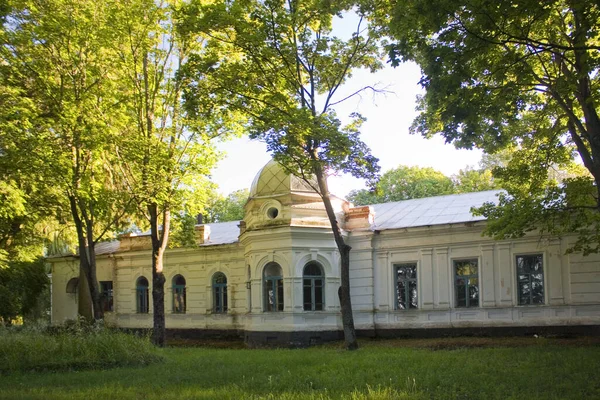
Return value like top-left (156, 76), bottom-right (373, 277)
top-left (371, 190), bottom-right (502, 230)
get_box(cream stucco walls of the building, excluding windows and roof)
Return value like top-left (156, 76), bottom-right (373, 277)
top-left (52, 219), bottom-right (600, 332)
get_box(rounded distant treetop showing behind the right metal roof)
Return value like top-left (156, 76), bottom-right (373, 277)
top-left (348, 165), bottom-right (454, 205)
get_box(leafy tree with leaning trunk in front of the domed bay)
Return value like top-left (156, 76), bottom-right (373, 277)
top-left (188, 0), bottom-right (381, 349)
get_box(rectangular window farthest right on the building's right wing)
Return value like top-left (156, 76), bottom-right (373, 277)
top-left (517, 254), bottom-right (544, 305)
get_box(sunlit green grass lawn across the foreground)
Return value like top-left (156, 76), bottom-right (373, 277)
top-left (0, 339), bottom-right (600, 400)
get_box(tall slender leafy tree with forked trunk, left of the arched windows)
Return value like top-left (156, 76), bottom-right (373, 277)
top-left (114, 0), bottom-right (234, 346)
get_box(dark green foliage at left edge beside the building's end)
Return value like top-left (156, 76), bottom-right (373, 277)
top-left (0, 258), bottom-right (50, 325)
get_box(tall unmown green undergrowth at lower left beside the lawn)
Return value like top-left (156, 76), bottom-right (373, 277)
top-left (0, 322), bottom-right (162, 374)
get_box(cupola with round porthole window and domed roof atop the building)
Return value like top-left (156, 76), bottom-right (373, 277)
top-left (244, 160), bottom-right (345, 231)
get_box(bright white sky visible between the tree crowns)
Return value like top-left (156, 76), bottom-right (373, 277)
top-left (212, 16), bottom-right (482, 197)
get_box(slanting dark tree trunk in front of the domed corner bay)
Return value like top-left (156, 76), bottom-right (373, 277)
top-left (315, 162), bottom-right (358, 350)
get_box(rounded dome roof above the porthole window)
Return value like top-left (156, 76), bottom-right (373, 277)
top-left (250, 160), bottom-right (316, 197)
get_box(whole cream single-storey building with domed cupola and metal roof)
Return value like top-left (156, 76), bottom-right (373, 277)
top-left (49, 161), bottom-right (600, 345)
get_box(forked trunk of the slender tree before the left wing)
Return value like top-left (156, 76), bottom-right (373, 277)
top-left (148, 203), bottom-right (170, 347)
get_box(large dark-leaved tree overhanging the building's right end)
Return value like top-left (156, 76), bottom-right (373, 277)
top-left (382, 0), bottom-right (600, 252)
